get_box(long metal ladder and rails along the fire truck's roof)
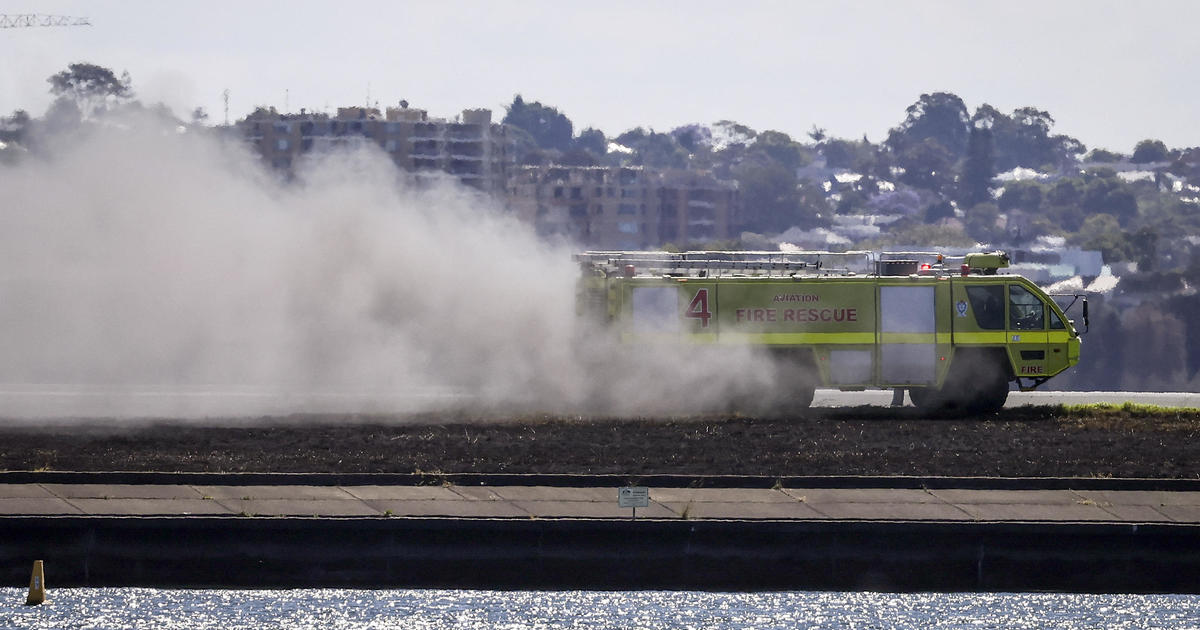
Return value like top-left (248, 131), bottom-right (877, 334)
top-left (575, 251), bottom-right (964, 276)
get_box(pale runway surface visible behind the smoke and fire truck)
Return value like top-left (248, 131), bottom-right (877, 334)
top-left (0, 384), bottom-right (1200, 421)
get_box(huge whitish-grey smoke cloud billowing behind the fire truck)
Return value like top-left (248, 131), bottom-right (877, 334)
top-left (0, 112), bottom-right (770, 415)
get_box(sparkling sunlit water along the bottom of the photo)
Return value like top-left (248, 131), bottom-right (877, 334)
top-left (0, 588), bottom-right (1200, 630)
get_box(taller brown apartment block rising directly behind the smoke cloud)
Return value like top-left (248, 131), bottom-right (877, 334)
top-left (236, 102), bottom-right (511, 193)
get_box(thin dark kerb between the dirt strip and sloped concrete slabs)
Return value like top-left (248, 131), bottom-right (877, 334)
top-left (0, 470), bottom-right (1200, 492)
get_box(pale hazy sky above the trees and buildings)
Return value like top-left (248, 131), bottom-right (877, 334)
top-left (0, 0), bottom-right (1200, 152)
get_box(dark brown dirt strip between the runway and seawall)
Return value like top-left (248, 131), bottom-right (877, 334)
top-left (0, 407), bottom-right (1200, 479)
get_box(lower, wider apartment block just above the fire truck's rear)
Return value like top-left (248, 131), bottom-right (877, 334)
top-left (508, 164), bottom-right (739, 250)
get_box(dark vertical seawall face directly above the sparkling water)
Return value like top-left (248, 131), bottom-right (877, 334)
top-left (0, 517), bottom-right (1200, 593)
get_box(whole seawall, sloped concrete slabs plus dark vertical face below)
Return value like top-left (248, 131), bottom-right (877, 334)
top-left (0, 474), bottom-right (1200, 593)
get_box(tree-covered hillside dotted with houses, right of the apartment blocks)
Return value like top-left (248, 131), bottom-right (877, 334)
top-left (504, 92), bottom-right (1200, 270)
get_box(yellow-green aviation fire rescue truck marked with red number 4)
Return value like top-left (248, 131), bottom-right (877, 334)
top-left (576, 252), bottom-right (1087, 412)
